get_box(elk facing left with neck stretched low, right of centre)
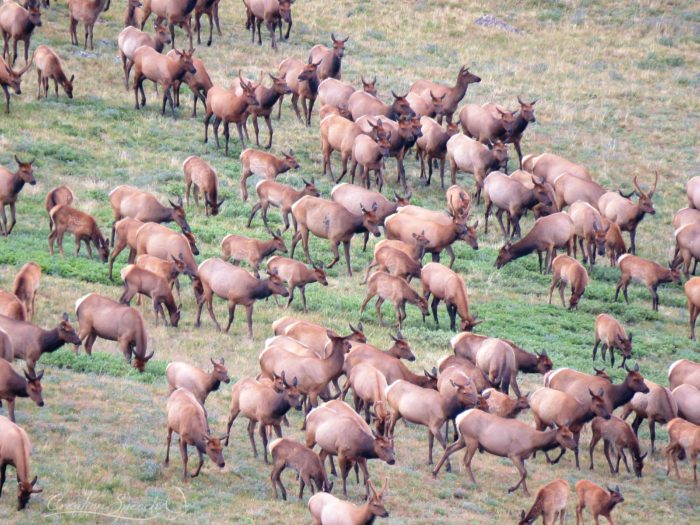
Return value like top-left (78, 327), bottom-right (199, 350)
top-left (496, 212), bottom-right (574, 272)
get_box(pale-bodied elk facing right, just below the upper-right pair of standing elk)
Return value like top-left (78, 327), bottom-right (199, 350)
top-left (447, 134), bottom-right (508, 204)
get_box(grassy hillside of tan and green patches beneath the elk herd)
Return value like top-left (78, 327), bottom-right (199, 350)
top-left (0, 0), bottom-right (700, 524)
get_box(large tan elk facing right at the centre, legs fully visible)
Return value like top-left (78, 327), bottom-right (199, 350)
top-left (291, 196), bottom-right (380, 275)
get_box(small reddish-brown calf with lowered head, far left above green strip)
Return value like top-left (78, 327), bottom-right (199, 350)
top-left (48, 204), bottom-right (109, 263)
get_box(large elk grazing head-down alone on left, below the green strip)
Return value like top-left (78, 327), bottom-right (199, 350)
top-left (74, 293), bottom-right (155, 373)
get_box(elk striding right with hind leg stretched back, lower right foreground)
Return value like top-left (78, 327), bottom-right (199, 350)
top-left (433, 409), bottom-right (575, 496)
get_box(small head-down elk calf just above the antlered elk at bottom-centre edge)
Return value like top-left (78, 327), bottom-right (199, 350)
top-left (268, 438), bottom-right (333, 501)
